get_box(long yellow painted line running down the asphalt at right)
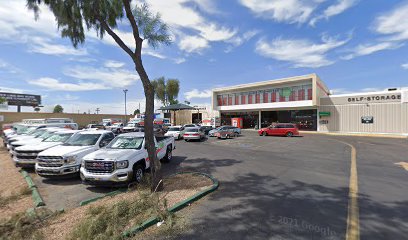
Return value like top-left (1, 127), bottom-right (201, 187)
top-left (342, 142), bottom-right (360, 240)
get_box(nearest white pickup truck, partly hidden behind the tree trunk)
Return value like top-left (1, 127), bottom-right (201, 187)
top-left (80, 132), bottom-right (175, 185)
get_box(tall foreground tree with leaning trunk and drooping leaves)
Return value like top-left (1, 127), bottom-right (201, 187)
top-left (27, 0), bottom-right (171, 190)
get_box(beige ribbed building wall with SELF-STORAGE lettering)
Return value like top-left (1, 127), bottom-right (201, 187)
top-left (319, 92), bottom-right (408, 134)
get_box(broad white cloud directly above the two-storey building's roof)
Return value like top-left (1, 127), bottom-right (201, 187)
top-left (255, 33), bottom-right (350, 68)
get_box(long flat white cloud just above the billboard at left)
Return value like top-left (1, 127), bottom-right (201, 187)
top-left (28, 77), bottom-right (108, 92)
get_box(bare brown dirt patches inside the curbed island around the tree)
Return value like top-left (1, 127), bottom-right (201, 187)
top-left (40, 174), bottom-right (212, 240)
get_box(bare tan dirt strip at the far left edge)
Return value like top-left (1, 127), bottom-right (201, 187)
top-left (0, 143), bottom-right (33, 221)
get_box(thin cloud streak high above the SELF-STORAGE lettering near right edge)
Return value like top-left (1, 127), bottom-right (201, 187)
top-left (341, 42), bottom-right (403, 60)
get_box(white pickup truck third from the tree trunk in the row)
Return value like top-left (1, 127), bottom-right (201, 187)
top-left (13, 129), bottom-right (78, 168)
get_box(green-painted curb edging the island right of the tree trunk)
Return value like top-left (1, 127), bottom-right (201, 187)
top-left (122, 172), bottom-right (219, 238)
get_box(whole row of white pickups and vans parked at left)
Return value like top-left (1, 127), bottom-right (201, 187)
top-left (3, 122), bottom-right (175, 185)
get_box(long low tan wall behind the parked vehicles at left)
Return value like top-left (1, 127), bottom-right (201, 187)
top-left (0, 112), bottom-right (131, 128)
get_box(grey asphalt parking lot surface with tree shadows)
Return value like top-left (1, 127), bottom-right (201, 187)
top-left (3, 131), bottom-right (408, 239)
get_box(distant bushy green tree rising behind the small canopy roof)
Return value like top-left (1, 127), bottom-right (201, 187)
top-left (152, 77), bottom-right (180, 106)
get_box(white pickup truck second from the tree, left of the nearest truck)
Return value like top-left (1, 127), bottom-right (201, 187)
top-left (35, 130), bottom-right (115, 177)
